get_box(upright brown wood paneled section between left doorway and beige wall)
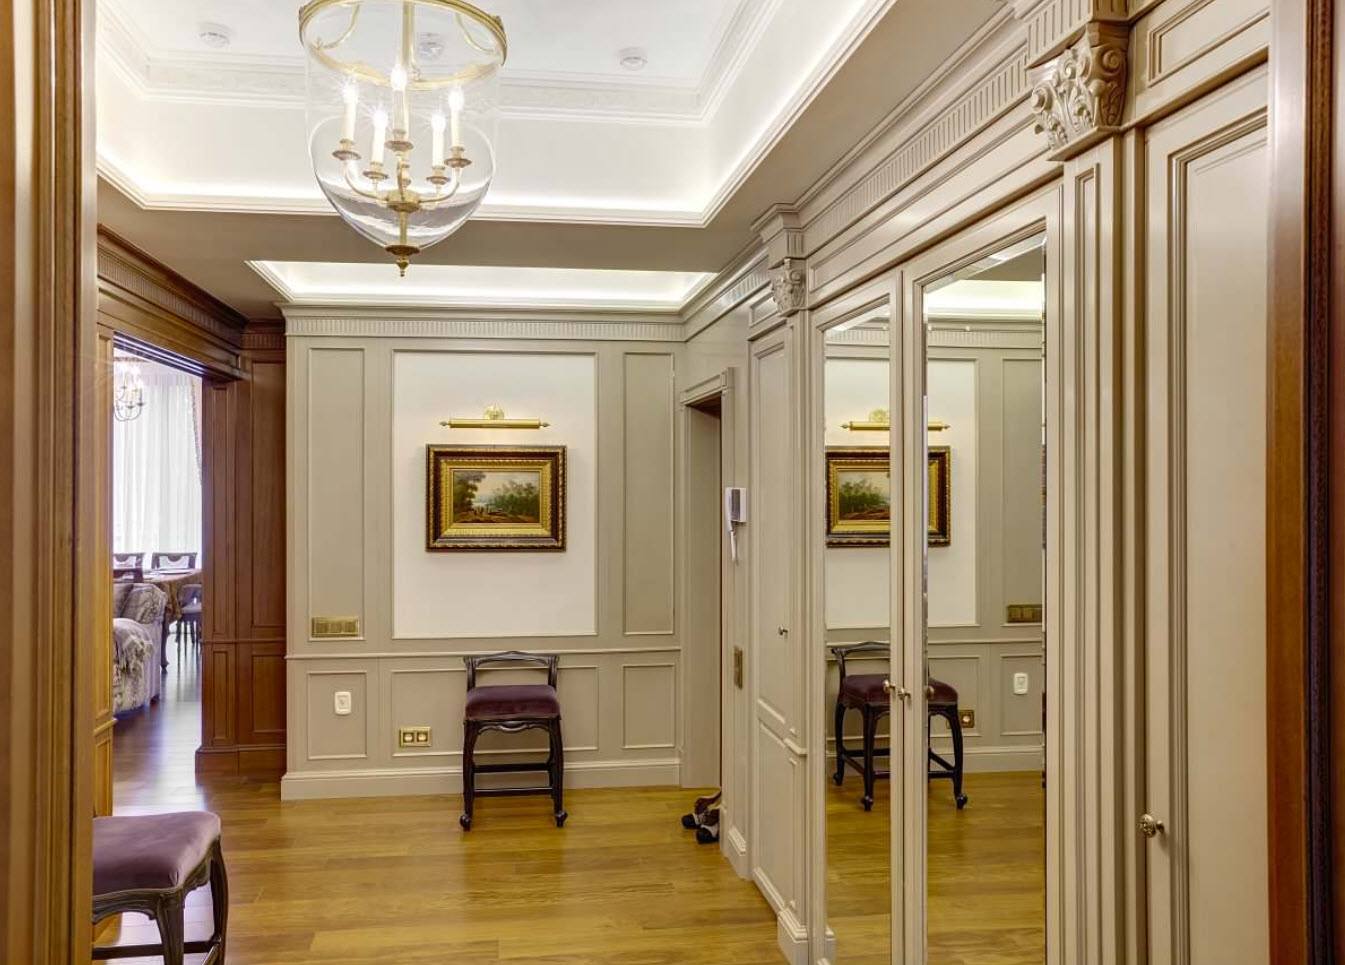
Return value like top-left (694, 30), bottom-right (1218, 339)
top-left (196, 323), bottom-right (285, 773)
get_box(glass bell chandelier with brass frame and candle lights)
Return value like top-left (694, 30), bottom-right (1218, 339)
top-left (299, 0), bottom-right (508, 275)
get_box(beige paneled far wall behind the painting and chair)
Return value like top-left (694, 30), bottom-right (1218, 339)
top-left (282, 331), bottom-right (683, 798)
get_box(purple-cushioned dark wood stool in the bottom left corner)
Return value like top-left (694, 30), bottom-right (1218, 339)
top-left (93, 812), bottom-right (229, 965)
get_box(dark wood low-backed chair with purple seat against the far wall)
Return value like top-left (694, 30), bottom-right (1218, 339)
top-left (459, 650), bottom-right (569, 830)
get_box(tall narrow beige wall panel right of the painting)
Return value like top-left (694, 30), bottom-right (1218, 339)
top-left (623, 353), bottom-right (675, 635)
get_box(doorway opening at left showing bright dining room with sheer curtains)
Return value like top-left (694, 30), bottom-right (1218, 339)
top-left (108, 336), bottom-right (206, 812)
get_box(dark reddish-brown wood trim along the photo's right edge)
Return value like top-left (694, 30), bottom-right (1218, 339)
top-left (1266, 0), bottom-right (1340, 965)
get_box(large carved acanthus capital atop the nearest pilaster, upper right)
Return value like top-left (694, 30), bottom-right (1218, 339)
top-left (1032, 23), bottom-right (1128, 159)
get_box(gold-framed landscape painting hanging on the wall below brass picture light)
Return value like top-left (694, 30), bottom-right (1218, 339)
top-left (425, 445), bottom-right (565, 552)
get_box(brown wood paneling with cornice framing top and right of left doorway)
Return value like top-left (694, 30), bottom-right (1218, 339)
top-left (98, 230), bottom-right (285, 773)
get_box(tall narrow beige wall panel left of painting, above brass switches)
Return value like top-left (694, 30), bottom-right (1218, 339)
top-left (301, 347), bottom-right (366, 629)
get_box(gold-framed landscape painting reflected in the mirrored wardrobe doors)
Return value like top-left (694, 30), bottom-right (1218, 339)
top-left (827, 445), bottom-right (952, 546)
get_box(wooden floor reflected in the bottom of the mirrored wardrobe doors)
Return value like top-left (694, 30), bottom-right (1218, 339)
top-left (827, 773), bottom-right (1046, 965)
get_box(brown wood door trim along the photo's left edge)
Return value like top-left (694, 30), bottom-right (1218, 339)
top-left (0, 0), bottom-right (97, 965)
